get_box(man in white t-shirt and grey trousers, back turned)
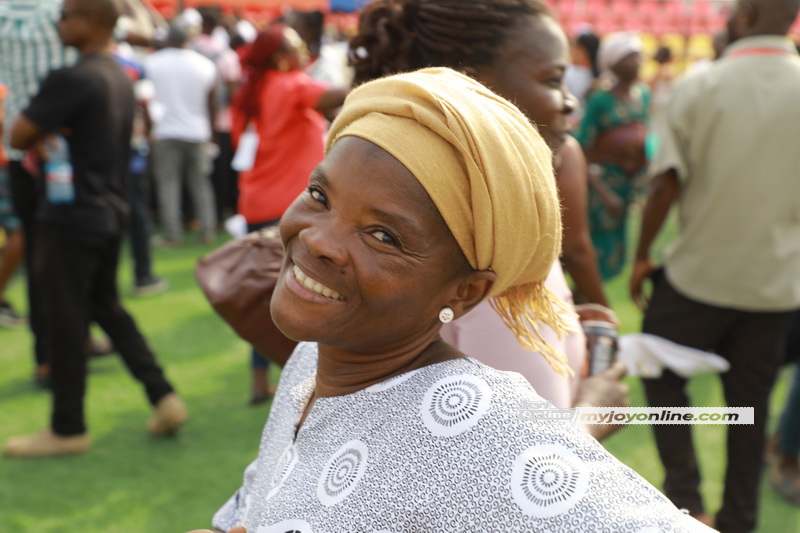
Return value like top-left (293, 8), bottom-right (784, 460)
top-left (144, 21), bottom-right (217, 246)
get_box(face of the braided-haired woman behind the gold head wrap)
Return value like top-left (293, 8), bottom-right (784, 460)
top-left (476, 16), bottom-right (576, 150)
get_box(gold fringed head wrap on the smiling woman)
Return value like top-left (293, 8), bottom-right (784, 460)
top-left (327, 68), bottom-right (570, 373)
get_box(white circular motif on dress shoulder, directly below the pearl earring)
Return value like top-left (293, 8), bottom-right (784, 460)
top-left (421, 374), bottom-right (492, 437)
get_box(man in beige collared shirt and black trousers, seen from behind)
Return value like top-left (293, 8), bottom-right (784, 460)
top-left (631, 0), bottom-right (800, 533)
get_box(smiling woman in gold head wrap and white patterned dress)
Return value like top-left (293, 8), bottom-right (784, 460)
top-left (197, 68), bottom-right (707, 533)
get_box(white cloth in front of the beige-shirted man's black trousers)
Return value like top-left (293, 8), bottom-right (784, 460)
top-left (617, 333), bottom-right (731, 378)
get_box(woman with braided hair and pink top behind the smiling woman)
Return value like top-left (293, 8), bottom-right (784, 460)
top-left (350, 0), bottom-right (627, 438)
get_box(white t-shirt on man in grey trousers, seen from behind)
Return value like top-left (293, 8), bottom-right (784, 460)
top-left (144, 48), bottom-right (217, 142)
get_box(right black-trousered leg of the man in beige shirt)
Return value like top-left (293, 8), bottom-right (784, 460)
top-left (716, 312), bottom-right (793, 533)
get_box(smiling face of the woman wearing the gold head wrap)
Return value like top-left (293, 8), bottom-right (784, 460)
top-left (271, 137), bottom-right (466, 354)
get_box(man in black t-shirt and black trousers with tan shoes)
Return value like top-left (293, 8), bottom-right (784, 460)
top-left (5, 0), bottom-right (187, 457)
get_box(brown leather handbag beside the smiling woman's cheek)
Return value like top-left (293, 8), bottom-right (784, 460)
top-left (194, 227), bottom-right (297, 366)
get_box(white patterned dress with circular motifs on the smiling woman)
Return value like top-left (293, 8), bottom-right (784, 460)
top-left (213, 343), bottom-right (711, 533)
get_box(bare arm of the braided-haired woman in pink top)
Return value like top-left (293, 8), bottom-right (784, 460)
top-left (556, 137), bottom-right (608, 307)
